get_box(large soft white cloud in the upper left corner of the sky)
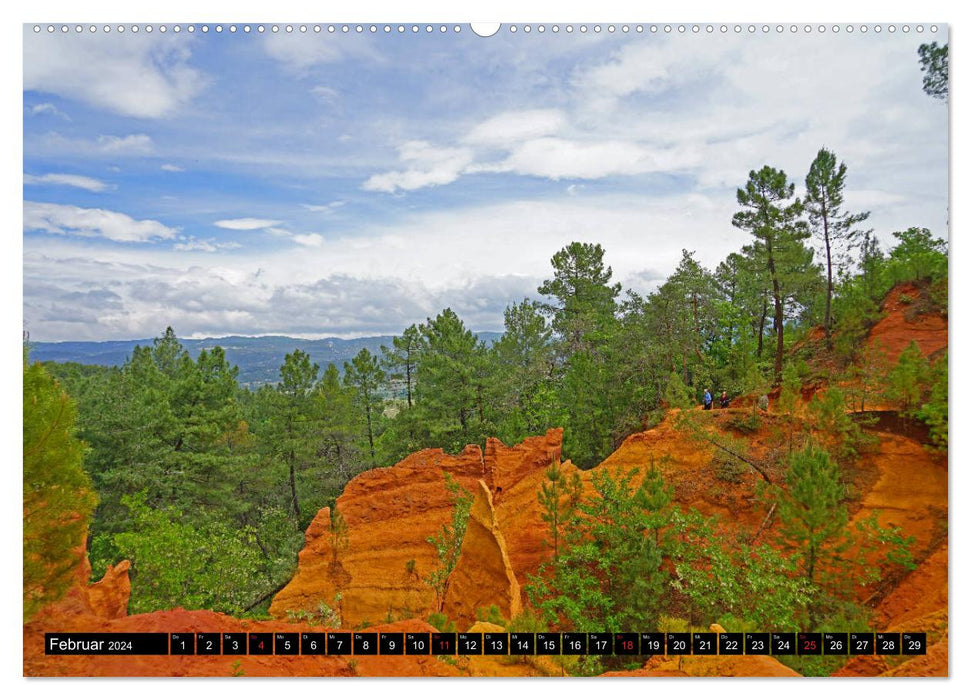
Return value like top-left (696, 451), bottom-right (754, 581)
top-left (24, 31), bottom-right (206, 119)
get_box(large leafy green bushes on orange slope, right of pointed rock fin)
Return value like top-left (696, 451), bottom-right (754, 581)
top-left (526, 466), bottom-right (810, 648)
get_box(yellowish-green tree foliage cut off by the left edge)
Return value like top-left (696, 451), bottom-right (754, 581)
top-left (23, 358), bottom-right (97, 622)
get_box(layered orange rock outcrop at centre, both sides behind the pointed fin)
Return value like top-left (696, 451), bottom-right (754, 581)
top-left (270, 429), bottom-right (563, 626)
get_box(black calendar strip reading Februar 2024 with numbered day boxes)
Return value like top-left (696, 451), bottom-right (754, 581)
top-left (44, 632), bottom-right (927, 656)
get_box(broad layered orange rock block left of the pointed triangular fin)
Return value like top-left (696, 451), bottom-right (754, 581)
top-left (270, 445), bottom-right (486, 626)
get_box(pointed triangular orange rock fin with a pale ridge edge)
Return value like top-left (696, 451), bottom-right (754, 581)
top-left (442, 481), bottom-right (522, 629)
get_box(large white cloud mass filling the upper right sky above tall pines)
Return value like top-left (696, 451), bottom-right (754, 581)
top-left (362, 35), bottom-right (947, 211)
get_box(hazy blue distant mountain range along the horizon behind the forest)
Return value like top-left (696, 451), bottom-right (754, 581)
top-left (30, 331), bottom-right (502, 387)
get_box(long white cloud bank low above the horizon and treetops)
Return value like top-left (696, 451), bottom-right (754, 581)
top-left (24, 175), bottom-right (936, 340)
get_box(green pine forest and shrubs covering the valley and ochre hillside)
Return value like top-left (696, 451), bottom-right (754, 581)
top-left (24, 148), bottom-right (948, 644)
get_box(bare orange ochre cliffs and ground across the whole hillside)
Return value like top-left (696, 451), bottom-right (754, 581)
top-left (23, 286), bottom-right (948, 676)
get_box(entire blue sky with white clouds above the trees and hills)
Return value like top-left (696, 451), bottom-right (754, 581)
top-left (23, 26), bottom-right (948, 341)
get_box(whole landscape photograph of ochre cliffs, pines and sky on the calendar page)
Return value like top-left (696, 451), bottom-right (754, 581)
top-left (22, 23), bottom-right (950, 682)
